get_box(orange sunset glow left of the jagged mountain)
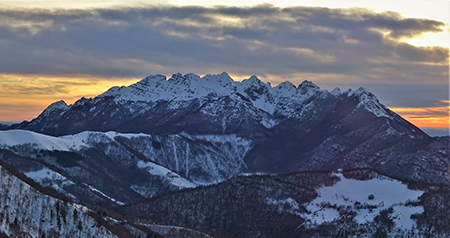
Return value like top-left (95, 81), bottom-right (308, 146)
top-left (0, 75), bottom-right (139, 122)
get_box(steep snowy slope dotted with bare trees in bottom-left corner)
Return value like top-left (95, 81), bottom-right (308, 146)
top-left (0, 166), bottom-right (117, 238)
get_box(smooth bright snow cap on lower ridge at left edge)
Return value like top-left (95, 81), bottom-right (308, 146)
top-left (0, 130), bottom-right (87, 151)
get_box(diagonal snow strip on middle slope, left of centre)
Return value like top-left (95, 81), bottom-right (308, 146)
top-left (137, 161), bottom-right (198, 188)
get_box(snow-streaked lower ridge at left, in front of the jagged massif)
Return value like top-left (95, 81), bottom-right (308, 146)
top-left (0, 130), bottom-right (251, 204)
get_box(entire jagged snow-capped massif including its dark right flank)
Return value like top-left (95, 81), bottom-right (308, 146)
top-left (4, 73), bottom-right (450, 183)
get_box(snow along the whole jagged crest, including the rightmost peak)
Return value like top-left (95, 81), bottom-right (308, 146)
top-left (37, 72), bottom-right (392, 122)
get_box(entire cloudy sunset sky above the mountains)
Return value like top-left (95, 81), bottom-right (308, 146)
top-left (0, 0), bottom-right (449, 136)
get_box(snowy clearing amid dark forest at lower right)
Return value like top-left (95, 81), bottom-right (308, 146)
top-left (267, 172), bottom-right (424, 233)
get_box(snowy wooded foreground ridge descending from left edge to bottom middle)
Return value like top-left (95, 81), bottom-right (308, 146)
top-left (0, 165), bottom-right (216, 238)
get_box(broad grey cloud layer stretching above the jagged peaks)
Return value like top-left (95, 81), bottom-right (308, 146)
top-left (0, 5), bottom-right (449, 107)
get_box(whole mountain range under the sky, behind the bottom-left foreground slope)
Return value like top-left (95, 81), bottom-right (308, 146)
top-left (0, 72), bottom-right (450, 237)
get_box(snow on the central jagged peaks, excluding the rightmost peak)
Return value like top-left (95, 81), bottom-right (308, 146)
top-left (99, 72), bottom-right (325, 114)
